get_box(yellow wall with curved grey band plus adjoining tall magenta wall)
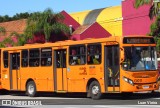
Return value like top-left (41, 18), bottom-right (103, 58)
top-left (70, 0), bottom-right (154, 36)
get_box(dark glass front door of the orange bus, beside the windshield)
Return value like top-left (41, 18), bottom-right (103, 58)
top-left (105, 45), bottom-right (120, 92)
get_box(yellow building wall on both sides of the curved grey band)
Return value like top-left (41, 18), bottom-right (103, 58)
top-left (70, 6), bottom-right (122, 36)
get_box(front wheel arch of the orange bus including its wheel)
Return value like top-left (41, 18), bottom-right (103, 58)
top-left (86, 78), bottom-right (102, 99)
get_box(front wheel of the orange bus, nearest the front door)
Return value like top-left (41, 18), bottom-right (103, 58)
top-left (89, 81), bottom-right (102, 99)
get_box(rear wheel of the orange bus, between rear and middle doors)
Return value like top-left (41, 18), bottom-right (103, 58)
top-left (26, 81), bottom-right (36, 97)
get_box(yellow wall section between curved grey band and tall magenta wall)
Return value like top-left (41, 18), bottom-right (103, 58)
top-left (97, 6), bottom-right (122, 36)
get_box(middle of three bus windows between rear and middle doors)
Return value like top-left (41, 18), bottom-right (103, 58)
top-left (29, 49), bottom-right (40, 67)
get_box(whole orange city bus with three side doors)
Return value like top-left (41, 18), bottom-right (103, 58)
top-left (1, 36), bottom-right (158, 99)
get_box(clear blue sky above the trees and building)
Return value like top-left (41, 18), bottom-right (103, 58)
top-left (0, 0), bottom-right (121, 16)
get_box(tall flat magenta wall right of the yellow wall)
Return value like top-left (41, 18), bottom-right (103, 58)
top-left (122, 0), bottom-right (154, 36)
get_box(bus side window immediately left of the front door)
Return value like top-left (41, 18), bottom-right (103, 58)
top-left (87, 44), bottom-right (101, 64)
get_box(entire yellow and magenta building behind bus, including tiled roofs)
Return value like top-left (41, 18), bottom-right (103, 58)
top-left (0, 0), bottom-right (154, 43)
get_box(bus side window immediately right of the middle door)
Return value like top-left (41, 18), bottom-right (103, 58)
top-left (69, 45), bottom-right (86, 65)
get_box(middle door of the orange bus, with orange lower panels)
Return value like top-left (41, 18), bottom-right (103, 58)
top-left (54, 49), bottom-right (67, 92)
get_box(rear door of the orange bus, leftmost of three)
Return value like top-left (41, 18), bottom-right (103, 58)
top-left (9, 53), bottom-right (20, 90)
